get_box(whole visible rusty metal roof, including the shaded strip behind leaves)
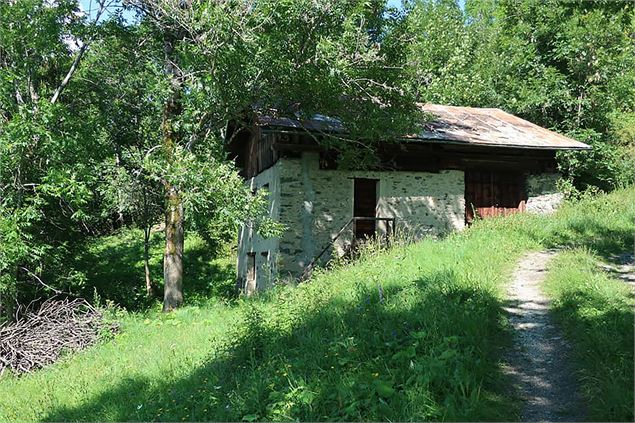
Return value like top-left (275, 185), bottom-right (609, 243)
top-left (256, 104), bottom-right (591, 150)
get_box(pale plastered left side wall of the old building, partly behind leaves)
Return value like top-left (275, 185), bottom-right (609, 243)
top-left (237, 162), bottom-right (280, 294)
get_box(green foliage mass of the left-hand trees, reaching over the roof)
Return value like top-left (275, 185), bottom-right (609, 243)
top-left (0, 0), bottom-right (422, 314)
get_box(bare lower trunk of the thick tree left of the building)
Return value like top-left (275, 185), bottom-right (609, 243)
top-left (163, 187), bottom-right (183, 312)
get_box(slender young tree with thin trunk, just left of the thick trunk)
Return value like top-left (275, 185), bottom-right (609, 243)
top-left (79, 19), bottom-right (163, 296)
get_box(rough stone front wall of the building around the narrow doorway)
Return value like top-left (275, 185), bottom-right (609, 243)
top-left (277, 152), bottom-right (465, 277)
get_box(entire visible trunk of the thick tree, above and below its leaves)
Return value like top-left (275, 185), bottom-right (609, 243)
top-left (162, 34), bottom-right (184, 312)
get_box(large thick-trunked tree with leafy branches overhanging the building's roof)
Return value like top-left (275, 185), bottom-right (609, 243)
top-left (125, 0), bottom-right (422, 311)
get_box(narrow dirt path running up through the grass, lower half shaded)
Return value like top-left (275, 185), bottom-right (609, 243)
top-left (505, 252), bottom-right (584, 422)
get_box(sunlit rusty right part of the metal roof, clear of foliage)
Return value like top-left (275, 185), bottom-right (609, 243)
top-left (418, 104), bottom-right (591, 150)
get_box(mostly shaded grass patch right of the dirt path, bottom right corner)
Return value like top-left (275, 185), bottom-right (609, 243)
top-left (553, 290), bottom-right (635, 421)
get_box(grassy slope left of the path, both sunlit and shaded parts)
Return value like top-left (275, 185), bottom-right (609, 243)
top-left (0, 190), bottom-right (635, 421)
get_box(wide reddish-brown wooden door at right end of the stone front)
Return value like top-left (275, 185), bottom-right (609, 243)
top-left (465, 170), bottom-right (527, 224)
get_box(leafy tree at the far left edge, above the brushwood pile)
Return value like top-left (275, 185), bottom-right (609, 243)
top-left (0, 0), bottom-right (114, 315)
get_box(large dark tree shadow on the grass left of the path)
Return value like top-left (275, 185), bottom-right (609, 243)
top-left (45, 272), bottom-right (517, 421)
